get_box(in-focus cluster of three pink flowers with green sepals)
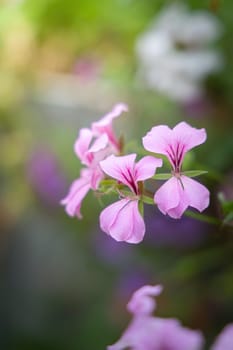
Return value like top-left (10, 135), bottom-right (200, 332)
top-left (61, 103), bottom-right (209, 243)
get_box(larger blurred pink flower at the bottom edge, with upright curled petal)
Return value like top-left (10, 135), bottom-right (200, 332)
top-left (107, 285), bottom-right (203, 350)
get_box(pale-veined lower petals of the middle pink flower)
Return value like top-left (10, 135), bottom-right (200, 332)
top-left (100, 198), bottom-right (145, 243)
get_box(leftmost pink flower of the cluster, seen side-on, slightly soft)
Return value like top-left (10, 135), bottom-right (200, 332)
top-left (61, 103), bottom-right (128, 218)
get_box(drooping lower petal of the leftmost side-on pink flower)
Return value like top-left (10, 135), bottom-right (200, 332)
top-left (61, 170), bottom-right (91, 219)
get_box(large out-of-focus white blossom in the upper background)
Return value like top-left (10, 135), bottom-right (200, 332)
top-left (136, 4), bottom-right (222, 102)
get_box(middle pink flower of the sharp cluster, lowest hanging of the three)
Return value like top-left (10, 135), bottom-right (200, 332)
top-left (100, 154), bottom-right (162, 243)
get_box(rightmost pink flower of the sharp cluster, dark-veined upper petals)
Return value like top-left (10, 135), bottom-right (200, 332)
top-left (143, 122), bottom-right (209, 219)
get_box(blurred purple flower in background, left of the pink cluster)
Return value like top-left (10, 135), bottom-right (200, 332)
top-left (26, 148), bottom-right (67, 205)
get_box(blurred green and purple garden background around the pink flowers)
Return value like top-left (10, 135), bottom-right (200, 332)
top-left (0, 0), bottom-right (233, 350)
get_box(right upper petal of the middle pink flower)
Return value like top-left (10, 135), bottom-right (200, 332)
top-left (135, 156), bottom-right (163, 181)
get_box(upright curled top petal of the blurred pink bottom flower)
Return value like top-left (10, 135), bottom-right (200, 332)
top-left (127, 285), bottom-right (163, 315)
